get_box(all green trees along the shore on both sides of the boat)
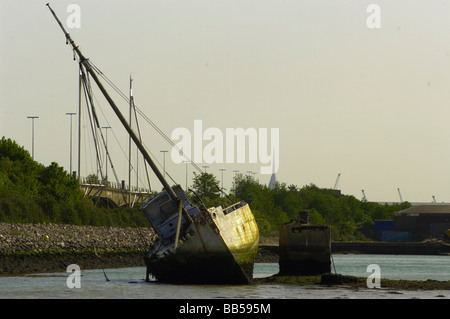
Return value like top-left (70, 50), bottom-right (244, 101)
top-left (0, 137), bottom-right (411, 240)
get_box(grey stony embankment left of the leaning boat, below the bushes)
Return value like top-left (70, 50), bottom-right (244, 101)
top-left (0, 223), bottom-right (155, 275)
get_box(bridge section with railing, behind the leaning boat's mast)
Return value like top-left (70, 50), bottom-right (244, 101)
top-left (80, 183), bottom-right (154, 208)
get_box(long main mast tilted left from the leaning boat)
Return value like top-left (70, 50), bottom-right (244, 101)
top-left (47, 3), bottom-right (180, 202)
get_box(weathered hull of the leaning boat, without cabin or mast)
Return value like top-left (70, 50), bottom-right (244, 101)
top-left (145, 203), bottom-right (259, 284)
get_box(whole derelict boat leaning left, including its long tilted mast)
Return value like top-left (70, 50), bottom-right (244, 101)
top-left (47, 4), bottom-right (259, 284)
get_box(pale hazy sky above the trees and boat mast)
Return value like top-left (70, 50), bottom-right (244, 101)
top-left (0, 0), bottom-right (450, 202)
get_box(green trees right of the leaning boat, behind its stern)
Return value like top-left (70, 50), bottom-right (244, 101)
top-left (188, 173), bottom-right (411, 240)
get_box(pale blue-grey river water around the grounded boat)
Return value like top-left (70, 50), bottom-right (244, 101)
top-left (0, 254), bottom-right (450, 299)
